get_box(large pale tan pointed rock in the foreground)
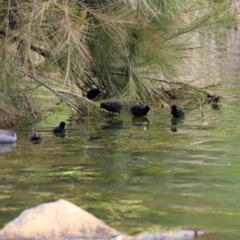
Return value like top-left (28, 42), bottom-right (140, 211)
top-left (0, 200), bottom-right (123, 240)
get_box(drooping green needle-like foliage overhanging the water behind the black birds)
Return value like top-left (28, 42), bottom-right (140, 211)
top-left (0, 0), bottom-right (236, 124)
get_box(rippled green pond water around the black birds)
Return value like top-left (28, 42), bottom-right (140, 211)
top-left (0, 27), bottom-right (240, 240)
